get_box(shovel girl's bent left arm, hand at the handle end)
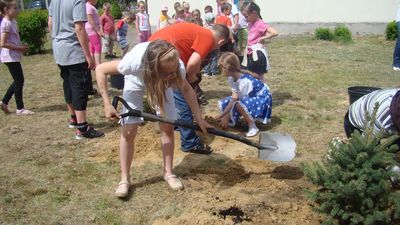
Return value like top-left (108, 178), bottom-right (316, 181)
top-left (96, 60), bottom-right (121, 118)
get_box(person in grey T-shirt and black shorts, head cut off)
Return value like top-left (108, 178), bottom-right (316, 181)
top-left (48, 0), bottom-right (104, 139)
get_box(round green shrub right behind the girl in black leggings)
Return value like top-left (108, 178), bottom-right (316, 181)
top-left (16, 10), bottom-right (47, 55)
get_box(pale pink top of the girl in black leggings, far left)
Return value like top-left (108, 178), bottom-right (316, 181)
top-left (0, 17), bottom-right (22, 62)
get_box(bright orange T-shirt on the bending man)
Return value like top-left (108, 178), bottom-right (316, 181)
top-left (149, 22), bottom-right (214, 65)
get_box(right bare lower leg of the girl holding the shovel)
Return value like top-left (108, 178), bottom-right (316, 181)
top-left (160, 123), bottom-right (174, 177)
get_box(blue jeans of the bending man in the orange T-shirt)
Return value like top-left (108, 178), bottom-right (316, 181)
top-left (174, 90), bottom-right (201, 151)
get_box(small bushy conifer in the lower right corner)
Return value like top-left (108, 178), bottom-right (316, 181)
top-left (302, 108), bottom-right (400, 225)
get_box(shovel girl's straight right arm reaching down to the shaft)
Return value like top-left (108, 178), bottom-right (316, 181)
top-left (181, 79), bottom-right (213, 133)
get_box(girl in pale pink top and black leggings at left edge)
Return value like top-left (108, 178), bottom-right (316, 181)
top-left (0, 0), bottom-right (34, 116)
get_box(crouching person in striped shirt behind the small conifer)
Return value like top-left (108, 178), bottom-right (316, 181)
top-left (344, 88), bottom-right (400, 144)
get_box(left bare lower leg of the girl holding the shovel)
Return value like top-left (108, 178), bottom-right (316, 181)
top-left (119, 124), bottom-right (138, 182)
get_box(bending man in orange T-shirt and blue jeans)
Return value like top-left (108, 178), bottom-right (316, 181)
top-left (149, 22), bottom-right (229, 154)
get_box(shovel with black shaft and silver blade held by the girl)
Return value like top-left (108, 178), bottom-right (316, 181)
top-left (112, 96), bottom-right (296, 162)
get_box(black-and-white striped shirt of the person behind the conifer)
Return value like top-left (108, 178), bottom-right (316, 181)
top-left (349, 89), bottom-right (399, 137)
